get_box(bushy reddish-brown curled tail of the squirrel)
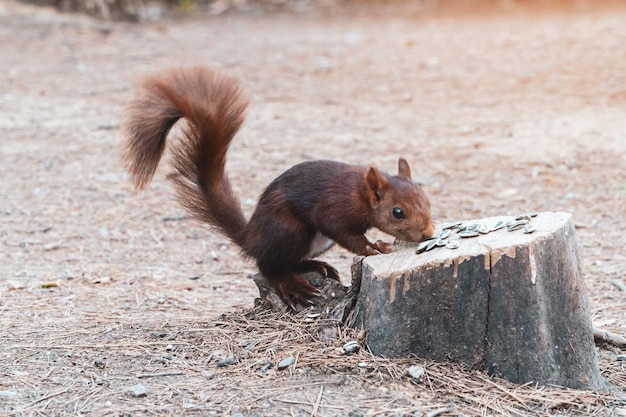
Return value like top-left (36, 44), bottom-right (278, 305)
top-left (123, 67), bottom-right (248, 246)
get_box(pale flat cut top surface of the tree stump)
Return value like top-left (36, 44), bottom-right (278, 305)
top-left (363, 212), bottom-right (572, 274)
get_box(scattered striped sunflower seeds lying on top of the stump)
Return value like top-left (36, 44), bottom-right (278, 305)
top-left (416, 211), bottom-right (539, 253)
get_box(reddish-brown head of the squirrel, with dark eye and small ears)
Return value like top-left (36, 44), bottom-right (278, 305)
top-left (365, 158), bottom-right (435, 242)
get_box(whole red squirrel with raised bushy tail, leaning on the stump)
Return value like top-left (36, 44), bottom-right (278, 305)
top-left (123, 67), bottom-right (434, 308)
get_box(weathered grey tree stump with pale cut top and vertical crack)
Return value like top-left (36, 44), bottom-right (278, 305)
top-left (348, 213), bottom-right (603, 389)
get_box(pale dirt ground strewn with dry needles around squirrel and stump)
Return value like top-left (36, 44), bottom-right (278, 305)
top-left (0, 0), bottom-right (626, 417)
